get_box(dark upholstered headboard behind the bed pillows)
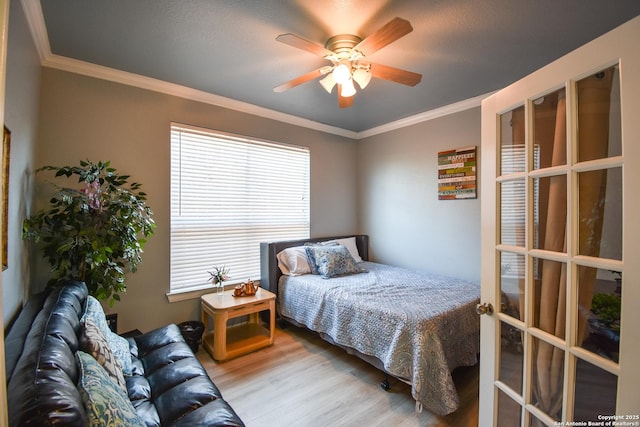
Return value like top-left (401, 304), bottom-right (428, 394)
top-left (260, 234), bottom-right (369, 295)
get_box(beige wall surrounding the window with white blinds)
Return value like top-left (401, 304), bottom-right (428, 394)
top-left (36, 68), bottom-right (358, 332)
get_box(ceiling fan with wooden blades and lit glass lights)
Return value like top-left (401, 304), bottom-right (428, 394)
top-left (273, 18), bottom-right (422, 108)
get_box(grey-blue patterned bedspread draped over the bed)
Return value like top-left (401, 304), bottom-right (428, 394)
top-left (278, 262), bottom-right (480, 415)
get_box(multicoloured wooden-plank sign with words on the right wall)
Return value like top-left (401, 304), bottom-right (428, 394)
top-left (438, 146), bottom-right (478, 200)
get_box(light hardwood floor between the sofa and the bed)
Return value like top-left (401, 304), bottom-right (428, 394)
top-left (197, 326), bottom-right (478, 427)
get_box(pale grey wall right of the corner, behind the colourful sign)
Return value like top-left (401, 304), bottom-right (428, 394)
top-left (358, 107), bottom-right (482, 281)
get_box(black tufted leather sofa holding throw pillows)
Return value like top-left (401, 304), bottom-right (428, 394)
top-left (5, 282), bottom-right (244, 427)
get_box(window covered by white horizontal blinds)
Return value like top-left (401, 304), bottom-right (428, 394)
top-left (170, 124), bottom-right (309, 293)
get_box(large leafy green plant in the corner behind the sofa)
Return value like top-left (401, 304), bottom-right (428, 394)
top-left (23, 161), bottom-right (155, 305)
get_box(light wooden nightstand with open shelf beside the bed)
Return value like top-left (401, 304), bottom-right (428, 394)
top-left (200, 288), bottom-right (276, 360)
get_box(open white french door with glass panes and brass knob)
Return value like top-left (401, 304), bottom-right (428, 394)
top-left (479, 17), bottom-right (640, 427)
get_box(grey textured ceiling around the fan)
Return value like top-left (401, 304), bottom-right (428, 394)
top-left (40, 0), bottom-right (640, 132)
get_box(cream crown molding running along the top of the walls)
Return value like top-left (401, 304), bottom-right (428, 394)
top-left (22, 0), bottom-right (490, 140)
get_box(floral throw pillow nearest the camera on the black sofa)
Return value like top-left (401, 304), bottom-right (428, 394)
top-left (76, 351), bottom-right (146, 427)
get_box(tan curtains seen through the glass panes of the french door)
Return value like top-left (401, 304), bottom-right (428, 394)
top-left (533, 69), bottom-right (613, 419)
